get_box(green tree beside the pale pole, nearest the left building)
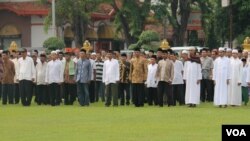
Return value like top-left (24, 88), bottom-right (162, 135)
top-left (40, 0), bottom-right (100, 46)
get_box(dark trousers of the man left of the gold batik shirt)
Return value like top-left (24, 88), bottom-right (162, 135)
top-left (118, 83), bottom-right (130, 105)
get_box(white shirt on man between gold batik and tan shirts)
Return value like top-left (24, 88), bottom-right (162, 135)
top-left (145, 64), bottom-right (158, 88)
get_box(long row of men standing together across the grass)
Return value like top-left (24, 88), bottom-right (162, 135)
top-left (0, 45), bottom-right (250, 107)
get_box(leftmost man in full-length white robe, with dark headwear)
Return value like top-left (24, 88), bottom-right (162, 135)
top-left (183, 51), bottom-right (202, 107)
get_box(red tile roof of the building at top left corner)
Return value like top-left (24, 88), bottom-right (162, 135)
top-left (0, 2), bottom-right (49, 16)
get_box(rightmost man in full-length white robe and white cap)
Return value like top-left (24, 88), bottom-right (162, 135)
top-left (228, 49), bottom-right (243, 106)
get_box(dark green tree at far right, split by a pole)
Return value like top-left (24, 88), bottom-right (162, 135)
top-left (215, 0), bottom-right (250, 44)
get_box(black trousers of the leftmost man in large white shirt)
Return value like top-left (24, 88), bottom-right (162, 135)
top-left (19, 80), bottom-right (33, 106)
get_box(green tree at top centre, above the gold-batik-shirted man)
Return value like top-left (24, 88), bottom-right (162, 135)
top-left (103, 0), bottom-right (151, 46)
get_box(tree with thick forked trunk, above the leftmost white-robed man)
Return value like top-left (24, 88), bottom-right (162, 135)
top-left (152, 0), bottom-right (211, 46)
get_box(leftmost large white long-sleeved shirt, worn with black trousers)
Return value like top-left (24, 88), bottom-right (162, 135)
top-left (17, 56), bottom-right (36, 81)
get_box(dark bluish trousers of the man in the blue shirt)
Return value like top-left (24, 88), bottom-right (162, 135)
top-left (77, 82), bottom-right (89, 106)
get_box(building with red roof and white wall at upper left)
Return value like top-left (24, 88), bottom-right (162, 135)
top-left (0, 0), bottom-right (53, 49)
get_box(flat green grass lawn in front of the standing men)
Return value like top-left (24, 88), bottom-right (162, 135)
top-left (0, 103), bottom-right (250, 141)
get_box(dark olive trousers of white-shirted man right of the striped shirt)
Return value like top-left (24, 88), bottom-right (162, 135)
top-left (105, 83), bottom-right (118, 106)
